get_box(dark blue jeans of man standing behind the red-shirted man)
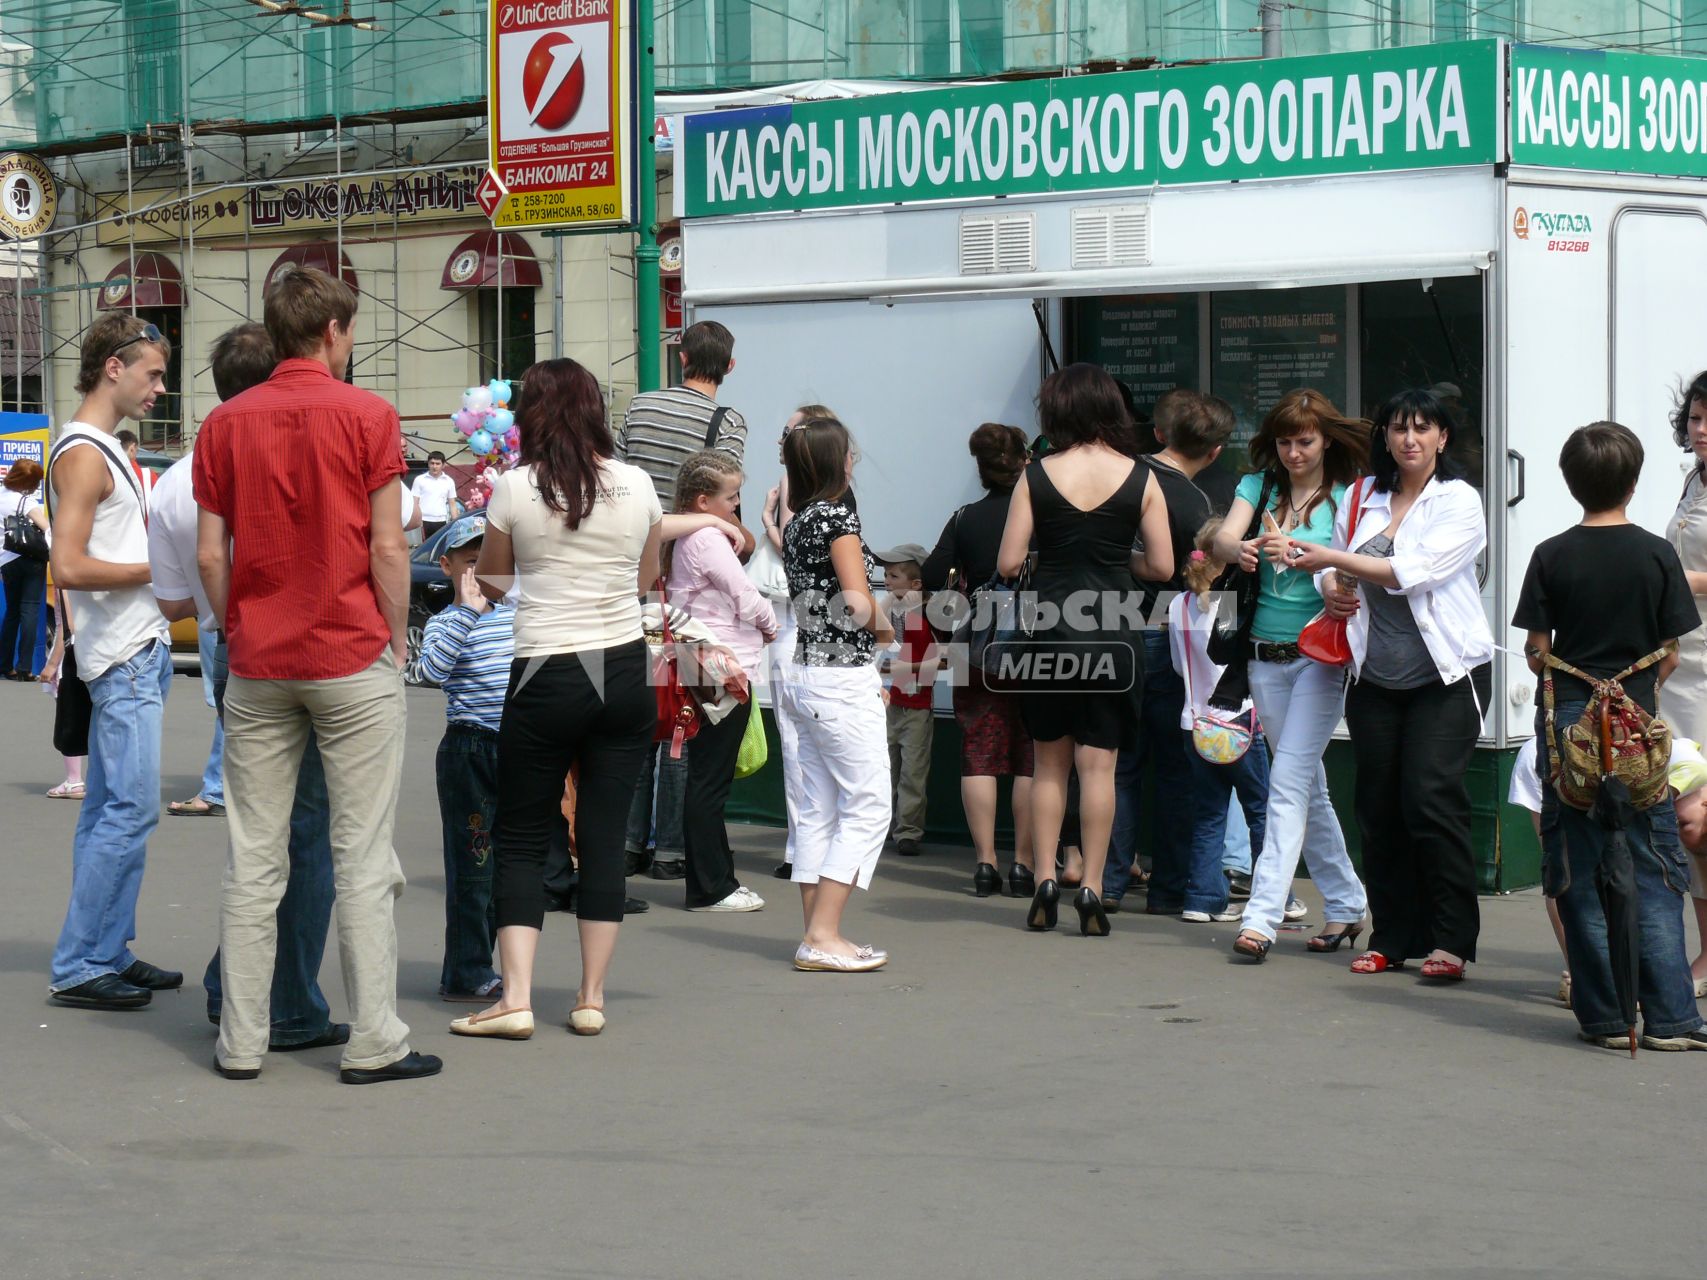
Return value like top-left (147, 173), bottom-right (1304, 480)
top-left (201, 643), bottom-right (336, 1048)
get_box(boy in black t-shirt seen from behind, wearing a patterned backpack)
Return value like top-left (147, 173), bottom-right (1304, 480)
top-left (1511, 422), bottom-right (1707, 1050)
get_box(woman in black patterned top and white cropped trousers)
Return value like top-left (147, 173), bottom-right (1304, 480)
top-left (782, 418), bottom-right (894, 973)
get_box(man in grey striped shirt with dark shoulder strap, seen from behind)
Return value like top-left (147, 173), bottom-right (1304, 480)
top-left (616, 321), bottom-right (746, 510)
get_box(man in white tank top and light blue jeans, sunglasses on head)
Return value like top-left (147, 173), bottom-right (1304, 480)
top-left (48, 312), bottom-right (184, 1009)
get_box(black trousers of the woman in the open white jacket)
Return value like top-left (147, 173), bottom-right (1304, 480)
top-left (1345, 664), bottom-right (1492, 961)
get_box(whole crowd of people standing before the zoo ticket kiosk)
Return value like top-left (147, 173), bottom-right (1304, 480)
top-left (13, 268), bottom-right (1707, 1084)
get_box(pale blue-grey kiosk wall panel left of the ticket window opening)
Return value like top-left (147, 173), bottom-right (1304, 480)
top-left (691, 300), bottom-right (1041, 550)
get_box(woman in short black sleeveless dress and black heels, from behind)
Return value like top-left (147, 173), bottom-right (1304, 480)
top-left (995, 364), bottom-right (1173, 937)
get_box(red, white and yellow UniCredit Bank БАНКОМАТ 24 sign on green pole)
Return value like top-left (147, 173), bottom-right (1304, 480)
top-left (486, 0), bottom-right (650, 227)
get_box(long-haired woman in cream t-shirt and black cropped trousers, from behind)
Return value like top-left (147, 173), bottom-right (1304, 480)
top-left (451, 360), bottom-right (740, 1039)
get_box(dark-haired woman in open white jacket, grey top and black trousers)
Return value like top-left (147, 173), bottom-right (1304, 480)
top-left (1297, 391), bottom-right (1494, 981)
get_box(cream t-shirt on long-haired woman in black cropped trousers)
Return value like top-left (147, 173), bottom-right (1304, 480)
top-left (486, 461), bottom-right (664, 657)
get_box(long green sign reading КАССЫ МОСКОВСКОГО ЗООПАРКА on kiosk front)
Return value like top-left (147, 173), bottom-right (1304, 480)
top-left (683, 39), bottom-right (1504, 217)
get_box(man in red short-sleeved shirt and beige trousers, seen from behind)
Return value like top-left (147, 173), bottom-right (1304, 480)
top-left (193, 268), bottom-right (442, 1084)
